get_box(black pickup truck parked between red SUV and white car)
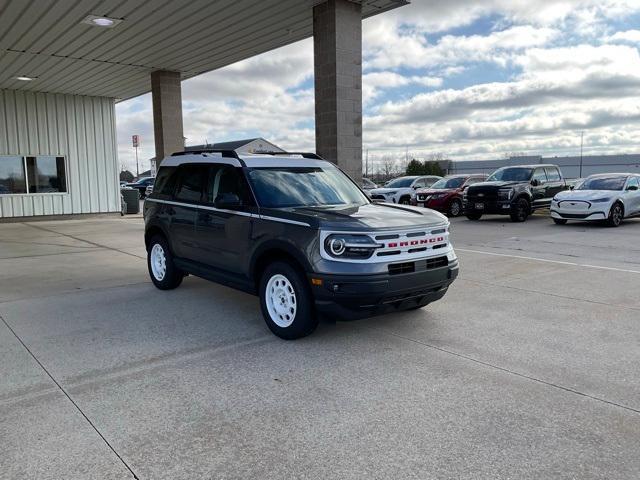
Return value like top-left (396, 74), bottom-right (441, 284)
top-left (463, 165), bottom-right (568, 222)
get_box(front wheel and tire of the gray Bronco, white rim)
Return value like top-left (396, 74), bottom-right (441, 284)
top-left (259, 261), bottom-right (318, 340)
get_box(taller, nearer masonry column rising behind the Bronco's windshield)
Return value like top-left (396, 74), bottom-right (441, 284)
top-left (313, 0), bottom-right (362, 182)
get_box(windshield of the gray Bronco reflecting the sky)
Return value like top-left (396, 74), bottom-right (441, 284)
top-left (249, 166), bottom-right (369, 208)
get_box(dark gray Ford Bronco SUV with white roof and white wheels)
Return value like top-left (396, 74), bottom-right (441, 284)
top-left (144, 150), bottom-right (458, 339)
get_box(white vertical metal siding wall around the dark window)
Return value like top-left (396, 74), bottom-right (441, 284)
top-left (0, 90), bottom-right (120, 218)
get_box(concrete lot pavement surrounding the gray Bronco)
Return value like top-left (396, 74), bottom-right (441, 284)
top-left (0, 215), bottom-right (640, 479)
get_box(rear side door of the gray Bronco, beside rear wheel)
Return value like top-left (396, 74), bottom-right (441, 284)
top-left (167, 164), bottom-right (206, 260)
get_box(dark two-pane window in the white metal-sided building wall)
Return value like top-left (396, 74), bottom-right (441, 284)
top-left (0, 155), bottom-right (67, 195)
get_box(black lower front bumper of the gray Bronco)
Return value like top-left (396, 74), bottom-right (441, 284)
top-left (309, 259), bottom-right (459, 320)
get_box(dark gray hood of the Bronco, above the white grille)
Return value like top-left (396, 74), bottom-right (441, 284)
top-left (279, 203), bottom-right (449, 231)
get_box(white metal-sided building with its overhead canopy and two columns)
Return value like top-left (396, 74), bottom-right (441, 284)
top-left (0, 0), bottom-right (409, 218)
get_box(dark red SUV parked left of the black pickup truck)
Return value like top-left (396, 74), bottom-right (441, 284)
top-left (412, 174), bottom-right (487, 217)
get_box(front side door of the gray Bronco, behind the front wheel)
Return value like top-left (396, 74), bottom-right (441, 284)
top-left (196, 164), bottom-right (257, 273)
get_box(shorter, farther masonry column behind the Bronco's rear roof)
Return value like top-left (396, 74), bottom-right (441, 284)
top-left (151, 70), bottom-right (184, 165)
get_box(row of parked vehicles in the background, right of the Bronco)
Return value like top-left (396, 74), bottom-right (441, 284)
top-left (404, 165), bottom-right (640, 226)
